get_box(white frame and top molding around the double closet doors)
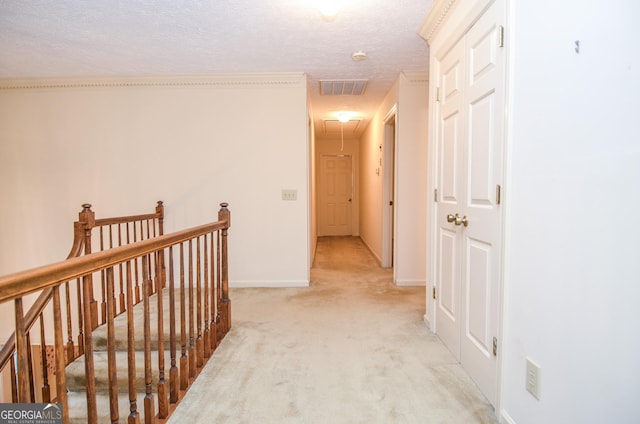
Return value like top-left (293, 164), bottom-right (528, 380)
top-left (419, 0), bottom-right (513, 417)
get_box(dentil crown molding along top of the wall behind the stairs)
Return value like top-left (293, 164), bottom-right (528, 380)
top-left (0, 72), bottom-right (306, 90)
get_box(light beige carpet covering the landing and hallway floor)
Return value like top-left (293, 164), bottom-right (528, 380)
top-left (168, 237), bottom-right (495, 424)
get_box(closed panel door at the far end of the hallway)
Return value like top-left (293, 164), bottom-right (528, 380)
top-left (318, 155), bottom-right (353, 236)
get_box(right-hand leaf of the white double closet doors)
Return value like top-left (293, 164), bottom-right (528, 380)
top-left (460, 0), bottom-right (505, 405)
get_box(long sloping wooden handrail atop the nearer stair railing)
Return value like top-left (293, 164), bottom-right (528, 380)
top-left (0, 221), bottom-right (228, 303)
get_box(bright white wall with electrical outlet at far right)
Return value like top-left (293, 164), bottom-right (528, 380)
top-left (501, 0), bottom-right (640, 424)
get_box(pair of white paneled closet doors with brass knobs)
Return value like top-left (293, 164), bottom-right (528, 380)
top-left (437, 2), bottom-right (504, 405)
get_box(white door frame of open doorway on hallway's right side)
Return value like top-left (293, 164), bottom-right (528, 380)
top-left (380, 105), bottom-right (398, 270)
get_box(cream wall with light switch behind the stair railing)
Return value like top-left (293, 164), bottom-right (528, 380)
top-left (0, 74), bottom-right (310, 286)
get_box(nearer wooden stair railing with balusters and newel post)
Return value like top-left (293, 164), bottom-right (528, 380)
top-left (0, 203), bottom-right (231, 423)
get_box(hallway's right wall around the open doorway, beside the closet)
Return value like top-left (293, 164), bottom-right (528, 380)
top-left (360, 73), bottom-right (428, 285)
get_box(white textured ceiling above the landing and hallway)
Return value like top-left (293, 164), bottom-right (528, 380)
top-left (0, 0), bottom-right (433, 135)
